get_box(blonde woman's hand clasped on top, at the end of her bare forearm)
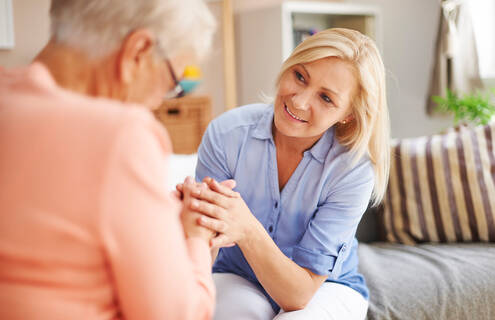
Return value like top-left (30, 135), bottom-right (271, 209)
top-left (190, 177), bottom-right (258, 248)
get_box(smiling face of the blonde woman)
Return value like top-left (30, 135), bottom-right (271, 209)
top-left (274, 57), bottom-right (357, 138)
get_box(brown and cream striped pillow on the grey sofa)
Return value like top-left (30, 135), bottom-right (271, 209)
top-left (381, 122), bottom-right (495, 244)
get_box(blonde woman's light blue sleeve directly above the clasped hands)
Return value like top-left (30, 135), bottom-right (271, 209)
top-left (196, 120), bottom-right (232, 181)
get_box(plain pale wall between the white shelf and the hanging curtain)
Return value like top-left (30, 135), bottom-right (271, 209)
top-left (347, 0), bottom-right (453, 138)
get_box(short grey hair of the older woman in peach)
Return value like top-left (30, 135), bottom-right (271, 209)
top-left (50, 0), bottom-right (215, 57)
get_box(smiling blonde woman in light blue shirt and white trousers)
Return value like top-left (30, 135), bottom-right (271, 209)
top-left (182, 29), bottom-right (389, 320)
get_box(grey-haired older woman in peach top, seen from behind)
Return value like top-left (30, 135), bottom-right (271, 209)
top-left (0, 0), bottom-right (214, 319)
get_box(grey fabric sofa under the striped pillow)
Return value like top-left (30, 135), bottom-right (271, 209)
top-left (357, 209), bottom-right (495, 320)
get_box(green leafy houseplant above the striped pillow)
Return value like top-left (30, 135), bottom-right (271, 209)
top-left (432, 89), bottom-right (495, 125)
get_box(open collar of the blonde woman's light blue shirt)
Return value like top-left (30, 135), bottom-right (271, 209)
top-left (253, 105), bottom-right (335, 163)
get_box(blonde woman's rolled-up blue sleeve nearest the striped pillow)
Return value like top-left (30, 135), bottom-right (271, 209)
top-left (292, 161), bottom-right (374, 279)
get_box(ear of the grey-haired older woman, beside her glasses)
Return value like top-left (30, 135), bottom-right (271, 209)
top-left (117, 29), bottom-right (155, 84)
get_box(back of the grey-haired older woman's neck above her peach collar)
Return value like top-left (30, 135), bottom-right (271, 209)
top-left (34, 41), bottom-right (117, 97)
